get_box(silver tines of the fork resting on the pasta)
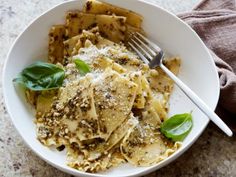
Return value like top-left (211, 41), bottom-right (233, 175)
top-left (128, 32), bottom-right (162, 64)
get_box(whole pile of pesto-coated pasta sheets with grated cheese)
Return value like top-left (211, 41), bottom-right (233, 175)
top-left (26, 0), bottom-right (181, 172)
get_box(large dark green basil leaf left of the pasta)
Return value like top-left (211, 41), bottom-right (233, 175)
top-left (13, 61), bottom-right (65, 91)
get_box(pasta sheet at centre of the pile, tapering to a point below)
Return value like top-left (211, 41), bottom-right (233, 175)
top-left (94, 68), bottom-right (137, 140)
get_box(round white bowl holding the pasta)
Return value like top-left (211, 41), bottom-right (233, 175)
top-left (3, 0), bottom-right (219, 176)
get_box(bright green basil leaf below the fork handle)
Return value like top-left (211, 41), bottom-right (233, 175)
top-left (161, 113), bottom-right (193, 141)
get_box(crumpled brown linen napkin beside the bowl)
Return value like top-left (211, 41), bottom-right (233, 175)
top-left (178, 0), bottom-right (236, 132)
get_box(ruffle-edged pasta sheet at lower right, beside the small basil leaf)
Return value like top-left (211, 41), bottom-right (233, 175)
top-left (121, 100), bottom-right (173, 166)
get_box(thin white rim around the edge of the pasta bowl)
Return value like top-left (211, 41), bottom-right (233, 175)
top-left (2, 0), bottom-right (220, 177)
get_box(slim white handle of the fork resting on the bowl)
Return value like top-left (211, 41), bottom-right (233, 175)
top-left (160, 63), bottom-right (233, 136)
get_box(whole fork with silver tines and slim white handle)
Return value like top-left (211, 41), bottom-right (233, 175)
top-left (128, 32), bottom-right (233, 136)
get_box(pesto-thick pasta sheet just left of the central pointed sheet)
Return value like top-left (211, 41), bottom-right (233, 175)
top-left (57, 76), bottom-right (100, 141)
